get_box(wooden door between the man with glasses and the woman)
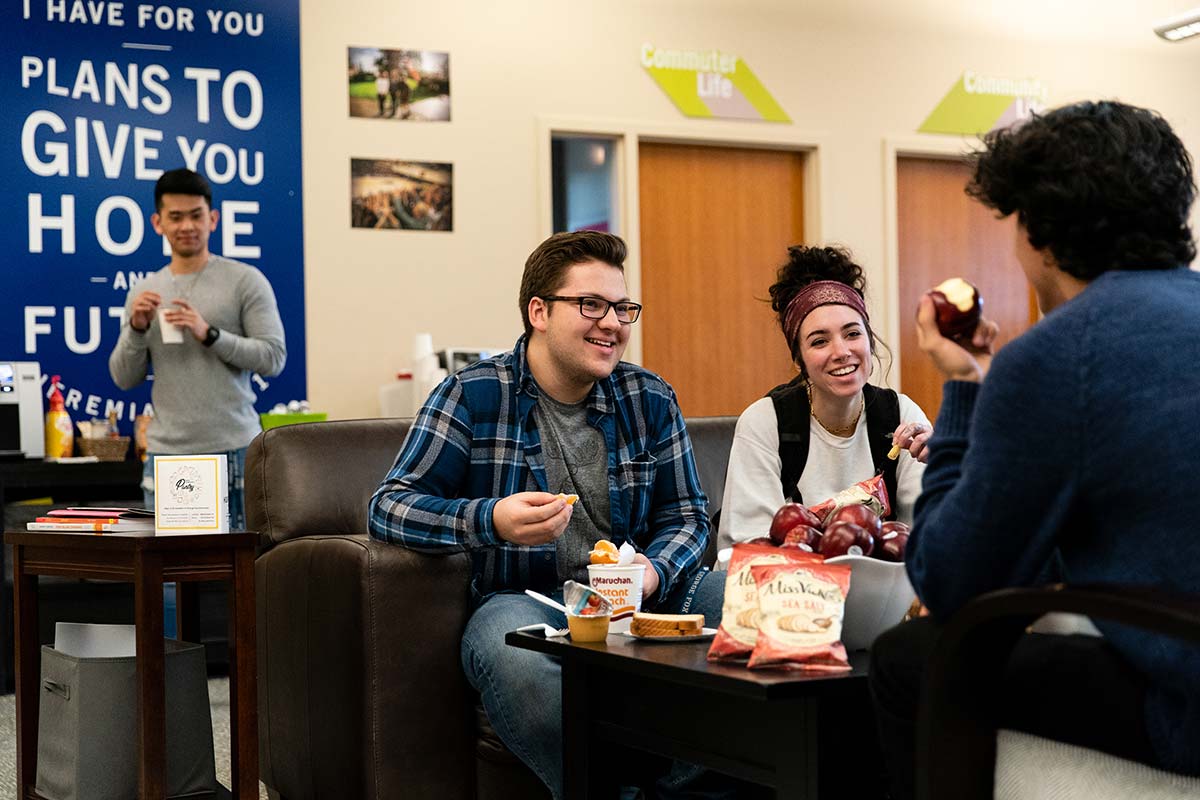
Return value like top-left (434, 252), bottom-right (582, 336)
top-left (638, 143), bottom-right (804, 416)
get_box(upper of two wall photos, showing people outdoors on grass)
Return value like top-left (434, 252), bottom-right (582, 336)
top-left (347, 47), bottom-right (450, 122)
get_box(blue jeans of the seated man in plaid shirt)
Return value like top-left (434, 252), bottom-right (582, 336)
top-left (461, 569), bottom-right (725, 798)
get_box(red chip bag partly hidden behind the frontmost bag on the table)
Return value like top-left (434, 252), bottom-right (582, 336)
top-left (708, 540), bottom-right (823, 661)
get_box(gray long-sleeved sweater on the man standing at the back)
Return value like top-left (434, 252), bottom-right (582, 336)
top-left (108, 255), bottom-right (287, 455)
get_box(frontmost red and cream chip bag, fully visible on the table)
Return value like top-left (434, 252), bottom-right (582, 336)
top-left (748, 563), bottom-right (850, 672)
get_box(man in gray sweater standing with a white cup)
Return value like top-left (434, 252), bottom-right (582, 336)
top-left (108, 169), bottom-right (287, 530)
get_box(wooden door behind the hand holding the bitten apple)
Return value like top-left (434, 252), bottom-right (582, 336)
top-left (896, 157), bottom-right (1038, 420)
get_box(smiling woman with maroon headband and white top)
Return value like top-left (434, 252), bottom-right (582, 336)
top-left (718, 245), bottom-right (932, 548)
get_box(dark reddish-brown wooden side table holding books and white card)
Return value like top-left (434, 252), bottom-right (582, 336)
top-left (5, 531), bottom-right (258, 800)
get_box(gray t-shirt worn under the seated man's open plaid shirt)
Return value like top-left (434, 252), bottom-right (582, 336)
top-left (534, 392), bottom-right (612, 583)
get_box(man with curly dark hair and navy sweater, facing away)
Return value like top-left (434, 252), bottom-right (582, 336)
top-left (871, 102), bottom-right (1200, 798)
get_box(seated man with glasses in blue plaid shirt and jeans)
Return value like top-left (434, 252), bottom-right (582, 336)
top-left (370, 231), bottom-right (724, 796)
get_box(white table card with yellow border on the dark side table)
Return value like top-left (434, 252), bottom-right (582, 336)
top-left (154, 455), bottom-right (229, 536)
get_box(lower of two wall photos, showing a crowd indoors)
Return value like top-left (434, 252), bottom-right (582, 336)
top-left (350, 158), bottom-right (454, 230)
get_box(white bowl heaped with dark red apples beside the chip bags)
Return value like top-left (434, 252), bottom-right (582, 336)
top-left (769, 503), bottom-right (917, 650)
